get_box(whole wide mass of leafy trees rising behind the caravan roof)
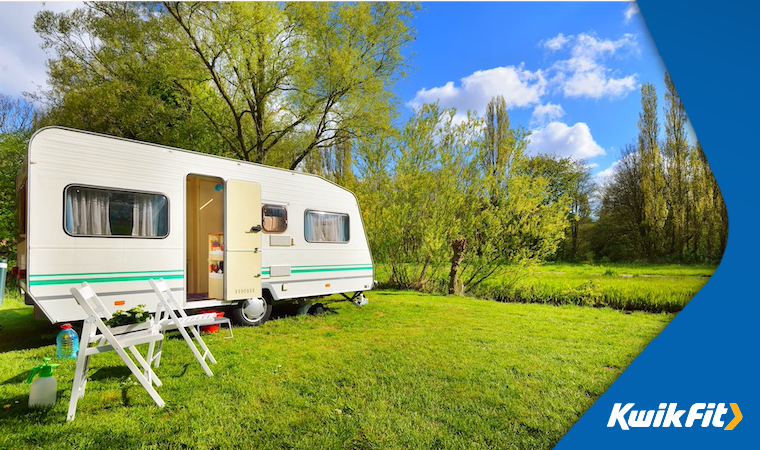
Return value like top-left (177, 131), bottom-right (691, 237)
top-left (35, 2), bottom-right (417, 168)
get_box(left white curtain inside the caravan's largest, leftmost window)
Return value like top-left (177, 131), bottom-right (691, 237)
top-left (66, 188), bottom-right (111, 236)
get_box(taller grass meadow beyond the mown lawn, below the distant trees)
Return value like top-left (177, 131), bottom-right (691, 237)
top-left (376, 263), bottom-right (717, 312)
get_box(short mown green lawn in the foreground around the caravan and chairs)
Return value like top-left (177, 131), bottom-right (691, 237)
top-left (0, 291), bottom-right (673, 449)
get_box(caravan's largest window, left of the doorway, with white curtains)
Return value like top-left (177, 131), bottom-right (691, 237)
top-left (64, 186), bottom-right (169, 238)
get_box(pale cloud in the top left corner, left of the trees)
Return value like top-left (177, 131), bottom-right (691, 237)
top-left (0, 2), bottom-right (82, 96)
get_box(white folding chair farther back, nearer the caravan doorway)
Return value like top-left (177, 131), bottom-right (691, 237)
top-left (148, 278), bottom-right (216, 376)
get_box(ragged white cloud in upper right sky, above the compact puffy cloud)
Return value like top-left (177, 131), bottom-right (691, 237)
top-left (552, 33), bottom-right (639, 99)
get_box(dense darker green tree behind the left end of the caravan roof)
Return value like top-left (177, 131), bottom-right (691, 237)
top-left (34, 2), bottom-right (220, 155)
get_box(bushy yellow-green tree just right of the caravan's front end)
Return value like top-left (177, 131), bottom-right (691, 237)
top-left (356, 100), bottom-right (569, 292)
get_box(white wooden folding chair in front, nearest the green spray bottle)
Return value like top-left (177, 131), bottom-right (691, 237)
top-left (67, 282), bottom-right (165, 420)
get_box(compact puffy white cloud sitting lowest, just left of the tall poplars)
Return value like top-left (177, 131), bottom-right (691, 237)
top-left (528, 122), bottom-right (605, 159)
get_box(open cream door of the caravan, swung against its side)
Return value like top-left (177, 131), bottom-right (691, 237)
top-left (224, 180), bottom-right (261, 300)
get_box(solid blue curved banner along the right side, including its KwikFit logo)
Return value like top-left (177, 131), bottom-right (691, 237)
top-left (557, 0), bottom-right (760, 449)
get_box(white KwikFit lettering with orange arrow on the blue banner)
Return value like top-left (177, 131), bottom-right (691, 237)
top-left (607, 403), bottom-right (742, 430)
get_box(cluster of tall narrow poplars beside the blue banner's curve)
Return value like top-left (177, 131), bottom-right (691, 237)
top-left (591, 73), bottom-right (728, 262)
